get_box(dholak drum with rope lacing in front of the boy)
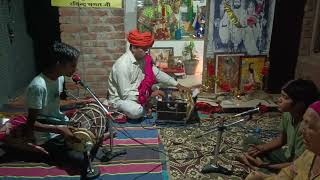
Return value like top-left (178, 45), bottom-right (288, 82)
top-left (67, 103), bottom-right (107, 152)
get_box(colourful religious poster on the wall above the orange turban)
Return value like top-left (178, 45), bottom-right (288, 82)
top-left (137, 0), bottom-right (206, 40)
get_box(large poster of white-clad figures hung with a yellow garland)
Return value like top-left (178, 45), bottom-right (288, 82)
top-left (213, 0), bottom-right (276, 55)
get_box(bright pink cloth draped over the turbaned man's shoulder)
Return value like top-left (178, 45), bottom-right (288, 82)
top-left (138, 54), bottom-right (156, 106)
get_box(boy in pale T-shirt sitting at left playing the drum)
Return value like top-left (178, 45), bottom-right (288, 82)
top-left (25, 42), bottom-right (88, 178)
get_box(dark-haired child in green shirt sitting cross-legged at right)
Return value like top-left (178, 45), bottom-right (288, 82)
top-left (239, 79), bottom-right (319, 173)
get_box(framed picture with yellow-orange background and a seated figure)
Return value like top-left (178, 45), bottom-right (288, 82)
top-left (240, 56), bottom-right (268, 92)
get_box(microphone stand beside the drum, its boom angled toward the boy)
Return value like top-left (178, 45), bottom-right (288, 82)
top-left (78, 81), bottom-right (127, 161)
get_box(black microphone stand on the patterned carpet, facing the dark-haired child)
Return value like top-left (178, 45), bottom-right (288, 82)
top-left (196, 115), bottom-right (252, 175)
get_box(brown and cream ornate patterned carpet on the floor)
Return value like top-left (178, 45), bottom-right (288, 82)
top-left (160, 112), bottom-right (280, 180)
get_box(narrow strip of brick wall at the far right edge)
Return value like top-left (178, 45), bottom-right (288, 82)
top-left (295, 0), bottom-right (320, 87)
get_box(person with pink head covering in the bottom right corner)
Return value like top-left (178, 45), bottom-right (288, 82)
top-left (246, 101), bottom-right (320, 180)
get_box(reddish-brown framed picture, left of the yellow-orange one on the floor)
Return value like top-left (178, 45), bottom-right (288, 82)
top-left (215, 53), bottom-right (244, 93)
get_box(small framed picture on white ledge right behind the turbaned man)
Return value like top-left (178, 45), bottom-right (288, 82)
top-left (150, 47), bottom-right (174, 69)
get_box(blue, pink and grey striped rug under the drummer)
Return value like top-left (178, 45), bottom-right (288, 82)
top-left (0, 111), bottom-right (168, 180)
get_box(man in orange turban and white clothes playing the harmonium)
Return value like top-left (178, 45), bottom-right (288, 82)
top-left (104, 30), bottom-right (190, 119)
